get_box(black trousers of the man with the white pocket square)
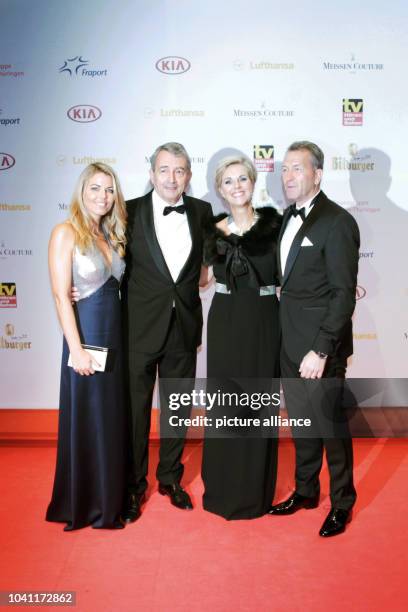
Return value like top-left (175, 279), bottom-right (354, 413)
top-left (281, 346), bottom-right (356, 510)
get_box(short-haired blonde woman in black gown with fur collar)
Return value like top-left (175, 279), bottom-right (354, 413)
top-left (202, 157), bottom-right (280, 519)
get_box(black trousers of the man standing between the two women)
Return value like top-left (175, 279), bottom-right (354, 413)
top-left (128, 309), bottom-right (197, 493)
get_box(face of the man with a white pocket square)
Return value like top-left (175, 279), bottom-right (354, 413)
top-left (282, 149), bottom-right (323, 204)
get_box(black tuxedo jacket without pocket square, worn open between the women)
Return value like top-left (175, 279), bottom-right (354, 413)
top-left (124, 192), bottom-right (211, 353)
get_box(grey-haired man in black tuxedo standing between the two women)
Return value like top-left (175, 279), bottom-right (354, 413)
top-left (122, 142), bottom-right (211, 523)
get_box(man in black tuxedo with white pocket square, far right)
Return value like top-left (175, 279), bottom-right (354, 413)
top-left (269, 141), bottom-right (360, 537)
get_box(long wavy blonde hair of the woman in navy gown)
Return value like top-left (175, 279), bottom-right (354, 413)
top-left (68, 162), bottom-right (127, 257)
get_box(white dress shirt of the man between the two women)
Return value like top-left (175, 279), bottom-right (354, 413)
top-left (152, 190), bottom-right (191, 281)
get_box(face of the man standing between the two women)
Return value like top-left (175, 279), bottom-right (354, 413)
top-left (150, 151), bottom-right (191, 204)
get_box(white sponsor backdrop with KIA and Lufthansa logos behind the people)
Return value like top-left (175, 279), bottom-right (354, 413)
top-left (0, 0), bottom-right (408, 408)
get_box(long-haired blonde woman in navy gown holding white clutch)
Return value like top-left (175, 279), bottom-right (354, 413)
top-left (46, 163), bottom-right (126, 531)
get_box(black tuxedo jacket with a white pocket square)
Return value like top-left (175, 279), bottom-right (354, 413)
top-left (278, 191), bottom-right (360, 363)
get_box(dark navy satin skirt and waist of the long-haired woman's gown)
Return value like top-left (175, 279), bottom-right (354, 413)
top-left (46, 246), bottom-right (125, 531)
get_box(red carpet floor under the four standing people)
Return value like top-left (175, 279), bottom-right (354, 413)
top-left (0, 439), bottom-right (408, 612)
